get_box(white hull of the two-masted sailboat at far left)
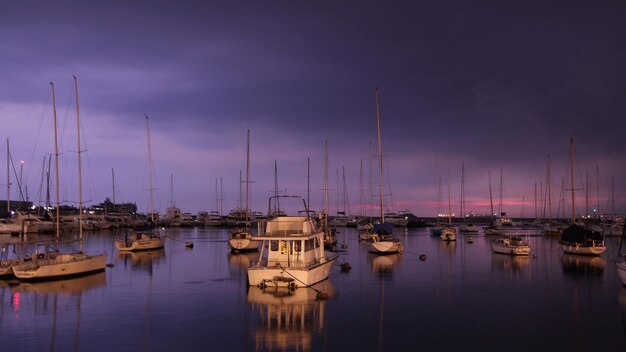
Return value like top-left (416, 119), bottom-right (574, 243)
top-left (13, 254), bottom-right (106, 280)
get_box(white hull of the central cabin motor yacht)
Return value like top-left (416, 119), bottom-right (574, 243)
top-left (248, 255), bottom-right (338, 287)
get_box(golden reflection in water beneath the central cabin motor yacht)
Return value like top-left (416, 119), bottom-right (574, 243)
top-left (248, 279), bottom-right (335, 351)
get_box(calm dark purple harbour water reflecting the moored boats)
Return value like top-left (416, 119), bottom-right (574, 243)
top-left (0, 228), bottom-right (626, 352)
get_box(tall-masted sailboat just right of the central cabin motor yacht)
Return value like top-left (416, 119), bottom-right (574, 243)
top-left (366, 89), bottom-right (403, 254)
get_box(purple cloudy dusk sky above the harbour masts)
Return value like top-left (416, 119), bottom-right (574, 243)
top-left (0, 1), bottom-right (626, 217)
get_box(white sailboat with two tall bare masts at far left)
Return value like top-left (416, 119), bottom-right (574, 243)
top-left (13, 77), bottom-right (106, 280)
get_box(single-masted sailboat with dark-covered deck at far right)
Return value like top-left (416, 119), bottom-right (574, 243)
top-left (559, 138), bottom-right (606, 255)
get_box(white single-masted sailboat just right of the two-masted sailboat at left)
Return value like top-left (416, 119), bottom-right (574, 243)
top-left (115, 115), bottom-right (165, 251)
